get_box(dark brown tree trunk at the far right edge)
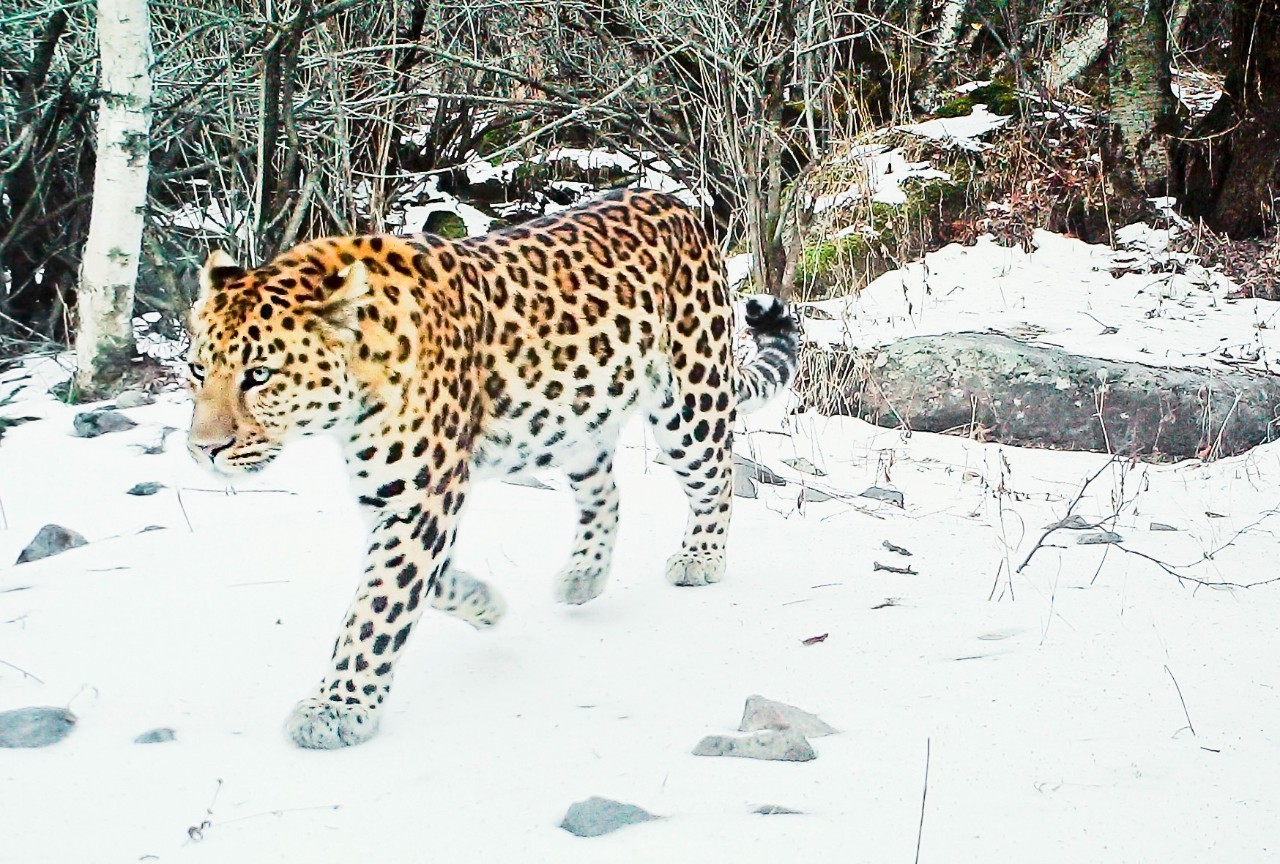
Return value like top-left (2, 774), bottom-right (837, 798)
top-left (1178, 0), bottom-right (1280, 238)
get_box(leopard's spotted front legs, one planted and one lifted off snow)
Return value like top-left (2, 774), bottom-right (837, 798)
top-left (285, 468), bottom-right (504, 749)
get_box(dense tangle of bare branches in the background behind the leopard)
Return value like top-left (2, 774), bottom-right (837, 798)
top-left (0, 0), bottom-right (1269, 355)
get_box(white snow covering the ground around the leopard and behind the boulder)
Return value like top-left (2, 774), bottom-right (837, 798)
top-left (0, 236), bottom-right (1280, 864)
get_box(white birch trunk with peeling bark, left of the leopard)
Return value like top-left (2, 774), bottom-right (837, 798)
top-left (76, 0), bottom-right (151, 401)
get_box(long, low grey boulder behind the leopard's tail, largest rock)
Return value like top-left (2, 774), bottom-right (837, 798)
top-left (795, 333), bottom-right (1280, 460)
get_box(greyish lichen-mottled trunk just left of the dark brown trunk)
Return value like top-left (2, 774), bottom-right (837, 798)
top-left (1107, 0), bottom-right (1175, 197)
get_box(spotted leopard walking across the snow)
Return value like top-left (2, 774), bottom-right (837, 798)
top-left (187, 189), bottom-right (800, 749)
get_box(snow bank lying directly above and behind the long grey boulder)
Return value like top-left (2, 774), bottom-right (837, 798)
top-left (805, 225), bottom-right (1280, 371)
